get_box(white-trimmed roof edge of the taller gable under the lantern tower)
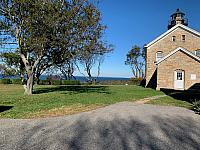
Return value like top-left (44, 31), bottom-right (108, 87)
top-left (145, 24), bottom-right (200, 48)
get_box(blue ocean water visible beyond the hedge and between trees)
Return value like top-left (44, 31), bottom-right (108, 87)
top-left (0, 75), bottom-right (130, 82)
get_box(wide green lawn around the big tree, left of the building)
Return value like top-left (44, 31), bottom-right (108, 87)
top-left (0, 85), bottom-right (163, 118)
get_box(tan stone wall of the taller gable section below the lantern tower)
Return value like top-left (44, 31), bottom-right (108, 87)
top-left (146, 27), bottom-right (200, 86)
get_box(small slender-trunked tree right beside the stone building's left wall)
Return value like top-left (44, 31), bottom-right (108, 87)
top-left (125, 45), bottom-right (145, 78)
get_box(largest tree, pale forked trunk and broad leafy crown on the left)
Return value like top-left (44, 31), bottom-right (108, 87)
top-left (0, 0), bottom-right (109, 95)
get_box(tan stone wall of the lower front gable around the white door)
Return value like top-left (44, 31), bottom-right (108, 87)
top-left (157, 51), bottom-right (200, 90)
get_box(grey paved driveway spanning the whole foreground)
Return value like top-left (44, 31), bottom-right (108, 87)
top-left (0, 102), bottom-right (200, 150)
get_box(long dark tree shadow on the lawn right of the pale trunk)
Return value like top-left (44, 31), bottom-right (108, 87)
top-left (33, 86), bottom-right (110, 94)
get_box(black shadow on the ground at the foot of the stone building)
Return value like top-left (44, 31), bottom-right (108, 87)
top-left (161, 89), bottom-right (200, 103)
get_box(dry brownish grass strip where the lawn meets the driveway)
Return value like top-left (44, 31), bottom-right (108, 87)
top-left (29, 104), bottom-right (106, 119)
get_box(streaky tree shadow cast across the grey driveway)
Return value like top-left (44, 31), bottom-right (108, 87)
top-left (14, 116), bottom-right (200, 150)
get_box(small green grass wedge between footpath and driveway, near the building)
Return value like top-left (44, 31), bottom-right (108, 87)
top-left (148, 96), bottom-right (192, 109)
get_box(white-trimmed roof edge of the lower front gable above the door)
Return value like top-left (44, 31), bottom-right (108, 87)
top-left (156, 47), bottom-right (200, 65)
